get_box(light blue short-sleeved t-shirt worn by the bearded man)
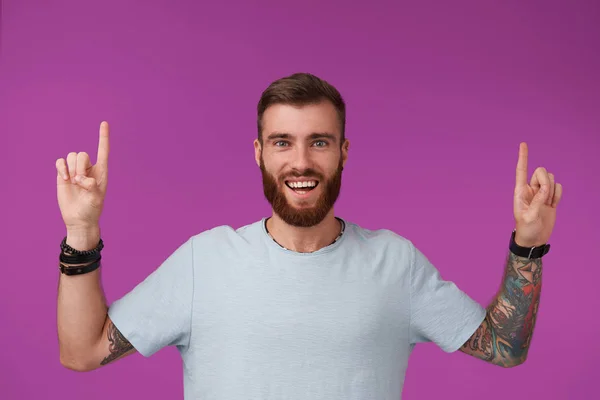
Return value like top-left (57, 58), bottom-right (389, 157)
top-left (109, 219), bottom-right (485, 400)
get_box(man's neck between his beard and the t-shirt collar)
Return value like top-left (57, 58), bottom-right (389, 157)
top-left (267, 208), bottom-right (341, 253)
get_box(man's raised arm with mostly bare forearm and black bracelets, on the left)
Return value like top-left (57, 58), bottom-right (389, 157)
top-left (56, 123), bottom-right (135, 371)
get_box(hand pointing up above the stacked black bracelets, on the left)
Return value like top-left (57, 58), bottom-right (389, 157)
top-left (56, 122), bottom-right (109, 233)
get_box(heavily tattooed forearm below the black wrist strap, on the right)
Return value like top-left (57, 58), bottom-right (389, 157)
top-left (461, 253), bottom-right (542, 367)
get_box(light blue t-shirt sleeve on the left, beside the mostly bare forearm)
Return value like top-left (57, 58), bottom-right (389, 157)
top-left (108, 238), bottom-right (194, 357)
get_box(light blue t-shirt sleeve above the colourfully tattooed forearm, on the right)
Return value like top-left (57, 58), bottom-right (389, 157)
top-left (410, 242), bottom-right (486, 353)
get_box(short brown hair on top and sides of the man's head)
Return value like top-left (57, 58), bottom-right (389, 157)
top-left (257, 73), bottom-right (346, 145)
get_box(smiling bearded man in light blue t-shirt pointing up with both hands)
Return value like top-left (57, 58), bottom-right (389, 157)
top-left (57, 74), bottom-right (562, 400)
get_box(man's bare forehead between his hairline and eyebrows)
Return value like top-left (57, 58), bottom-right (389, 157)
top-left (262, 102), bottom-right (341, 138)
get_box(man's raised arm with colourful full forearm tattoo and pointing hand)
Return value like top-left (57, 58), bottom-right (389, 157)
top-left (461, 143), bottom-right (562, 367)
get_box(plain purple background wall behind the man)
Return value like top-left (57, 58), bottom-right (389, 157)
top-left (0, 0), bottom-right (600, 400)
